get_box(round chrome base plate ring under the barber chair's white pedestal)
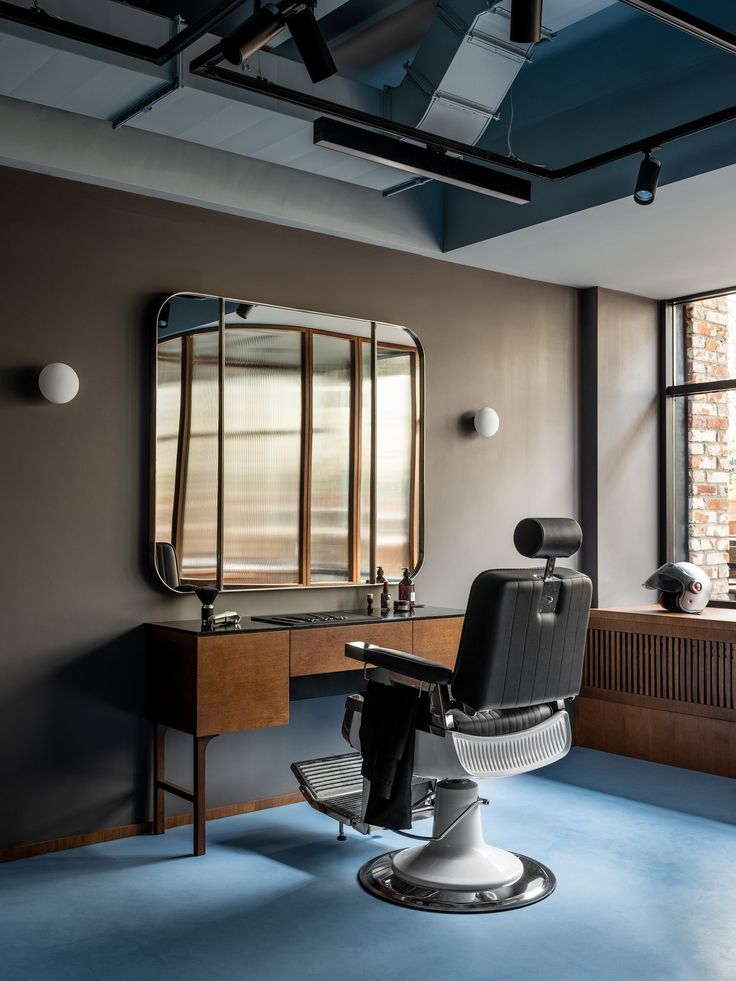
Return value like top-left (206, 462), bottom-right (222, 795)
top-left (358, 851), bottom-right (557, 913)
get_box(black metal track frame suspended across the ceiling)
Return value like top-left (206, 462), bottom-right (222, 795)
top-left (0, 0), bottom-right (736, 181)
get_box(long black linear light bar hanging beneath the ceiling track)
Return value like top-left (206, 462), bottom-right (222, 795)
top-left (314, 116), bottom-right (532, 204)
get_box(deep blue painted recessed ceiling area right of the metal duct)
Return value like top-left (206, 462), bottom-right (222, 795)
top-left (444, 0), bottom-right (736, 251)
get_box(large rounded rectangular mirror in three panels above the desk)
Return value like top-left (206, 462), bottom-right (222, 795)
top-left (151, 293), bottom-right (424, 591)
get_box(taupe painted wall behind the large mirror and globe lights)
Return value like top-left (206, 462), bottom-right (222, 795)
top-left (0, 169), bottom-right (576, 847)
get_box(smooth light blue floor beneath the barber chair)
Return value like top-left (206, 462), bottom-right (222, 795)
top-left (0, 749), bottom-right (736, 981)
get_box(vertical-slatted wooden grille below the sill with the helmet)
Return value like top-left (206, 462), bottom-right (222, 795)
top-left (583, 629), bottom-right (736, 710)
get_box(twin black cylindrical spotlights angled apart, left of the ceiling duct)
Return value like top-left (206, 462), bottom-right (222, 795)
top-left (221, 0), bottom-right (337, 83)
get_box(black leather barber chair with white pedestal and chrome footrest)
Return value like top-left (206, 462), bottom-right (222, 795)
top-left (292, 518), bottom-right (592, 913)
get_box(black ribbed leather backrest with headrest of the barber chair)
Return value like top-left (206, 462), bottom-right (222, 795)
top-left (452, 518), bottom-right (593, 711)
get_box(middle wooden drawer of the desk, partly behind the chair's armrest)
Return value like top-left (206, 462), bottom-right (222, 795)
top-left (291, 621), bottom-right (412, 677)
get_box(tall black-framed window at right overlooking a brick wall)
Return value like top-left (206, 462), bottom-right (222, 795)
top-left (665, 291), bottom-right (736, 603)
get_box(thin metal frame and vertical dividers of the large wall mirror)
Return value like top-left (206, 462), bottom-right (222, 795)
top-left (148, 290), bottom-right (426, 596)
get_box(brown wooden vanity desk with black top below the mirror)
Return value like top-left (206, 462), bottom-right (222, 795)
top-left (146, 607), bottom-right (463, 855)
